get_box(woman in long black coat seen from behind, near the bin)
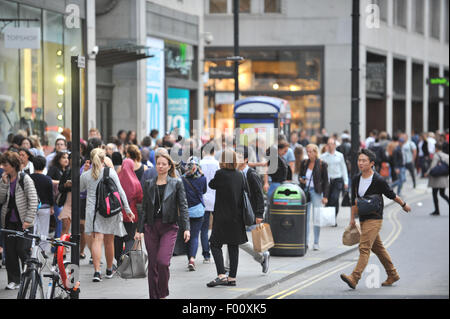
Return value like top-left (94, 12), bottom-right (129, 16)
top-left (207, 150), bottom-right (248, 287)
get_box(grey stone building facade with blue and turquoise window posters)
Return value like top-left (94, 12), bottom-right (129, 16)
top-left (96, 0), bottom-right (204, 139)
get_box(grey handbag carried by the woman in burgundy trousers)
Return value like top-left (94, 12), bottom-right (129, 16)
top-left (117, 240), bottom-right (148, 279)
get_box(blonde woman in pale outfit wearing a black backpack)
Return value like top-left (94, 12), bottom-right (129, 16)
top-left (80, 148), bottom-right (135, 282)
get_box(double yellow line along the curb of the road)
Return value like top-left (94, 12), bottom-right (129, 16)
top-left (267, 209), bottom-right (403, 299)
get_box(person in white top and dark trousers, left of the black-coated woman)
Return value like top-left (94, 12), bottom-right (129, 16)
top-left (200, 142), bottom-right (220, 264)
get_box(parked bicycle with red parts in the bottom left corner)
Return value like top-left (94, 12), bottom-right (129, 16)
top-left (0, 229), bottom-right (80, 299)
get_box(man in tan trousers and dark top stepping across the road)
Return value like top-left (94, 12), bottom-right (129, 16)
top-left (341, 149), bottom-right (411, 289)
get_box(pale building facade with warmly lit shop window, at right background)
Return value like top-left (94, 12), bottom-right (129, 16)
top-left (204, 0), bottom-right (449, 138)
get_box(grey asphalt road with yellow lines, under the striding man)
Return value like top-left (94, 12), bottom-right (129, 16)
top-left (251, 194), bottom-right (449, 299)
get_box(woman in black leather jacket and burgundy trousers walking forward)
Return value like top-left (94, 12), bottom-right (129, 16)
top-left (135, 152), bottom-right (191, 299)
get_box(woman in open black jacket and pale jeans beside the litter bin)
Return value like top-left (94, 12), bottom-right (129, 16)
top-left (299, 144), bottom-right (330, 250)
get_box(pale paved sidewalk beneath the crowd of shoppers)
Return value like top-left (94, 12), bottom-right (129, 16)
top-left (0, 176), bottom-right (431, 299)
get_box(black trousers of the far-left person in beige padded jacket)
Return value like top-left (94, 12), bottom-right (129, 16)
top-left (5, 222), bottom-right (33, 284)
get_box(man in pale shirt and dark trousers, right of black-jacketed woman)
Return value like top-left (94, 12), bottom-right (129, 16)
top-left (320, 137), bottom-right (348, 227)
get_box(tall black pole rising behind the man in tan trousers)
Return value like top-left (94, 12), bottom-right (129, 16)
top-left (351, 0), bottom-right (360, 177)
